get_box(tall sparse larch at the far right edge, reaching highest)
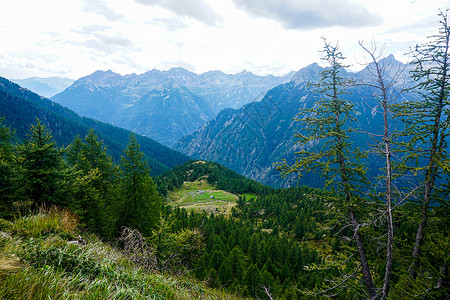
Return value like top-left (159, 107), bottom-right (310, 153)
top-left (396, 11), bottom-right (450, 279)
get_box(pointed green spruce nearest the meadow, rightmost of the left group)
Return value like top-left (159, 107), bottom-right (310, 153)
top-left (117, 134), bottom-right (162, 236)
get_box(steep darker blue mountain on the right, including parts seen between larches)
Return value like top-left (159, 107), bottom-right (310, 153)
top-left (173, 56), bottom-right (409, 187)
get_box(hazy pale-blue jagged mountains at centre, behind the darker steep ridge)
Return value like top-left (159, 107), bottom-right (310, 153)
top-left (51, 68), bottom-right (293, 146)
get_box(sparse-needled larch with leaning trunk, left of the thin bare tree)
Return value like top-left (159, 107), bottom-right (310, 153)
top-left (278, 40), bottom-right (377, 298)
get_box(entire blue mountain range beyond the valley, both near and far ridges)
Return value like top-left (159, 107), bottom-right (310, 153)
top-left (5, 55), bottom-right (410, 187)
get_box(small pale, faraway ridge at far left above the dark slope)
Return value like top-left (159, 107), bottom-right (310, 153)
top-left (11, 77), bottom-right (75, 98)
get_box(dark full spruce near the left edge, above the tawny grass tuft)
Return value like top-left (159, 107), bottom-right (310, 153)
top-left (19, 120), bottom-right (67, 208)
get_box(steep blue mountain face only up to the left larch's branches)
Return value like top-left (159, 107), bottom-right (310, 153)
top-left (174, 82), bottom-right (314, 186)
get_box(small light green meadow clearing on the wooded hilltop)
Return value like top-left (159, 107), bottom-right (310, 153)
top-left (167, 180), bottom-right (238, 214)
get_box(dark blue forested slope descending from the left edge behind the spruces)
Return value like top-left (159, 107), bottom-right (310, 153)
top-left (0, 77), bottom-right (188, 174)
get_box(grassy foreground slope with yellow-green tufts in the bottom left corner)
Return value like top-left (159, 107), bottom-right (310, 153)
top-left (0, 210), bottom-right (243, 299)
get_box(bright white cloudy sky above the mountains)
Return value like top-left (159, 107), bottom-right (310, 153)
top-left (0, 0), bottom-right (450, 79)
